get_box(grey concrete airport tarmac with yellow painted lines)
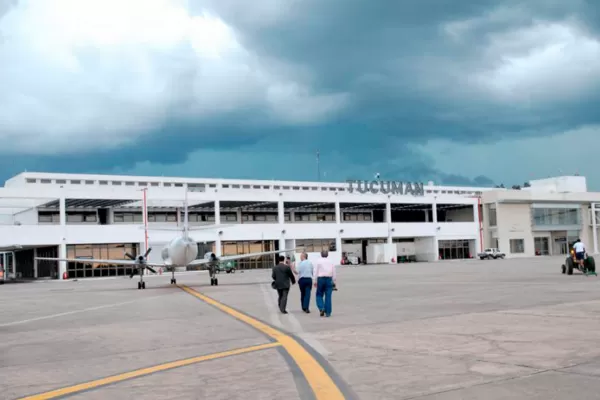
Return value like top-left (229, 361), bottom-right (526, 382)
top-left (0, 257), bottom-right (600, 400)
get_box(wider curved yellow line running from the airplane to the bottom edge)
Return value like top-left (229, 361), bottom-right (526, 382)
top-left (179, 286), bottom-right (345, 400)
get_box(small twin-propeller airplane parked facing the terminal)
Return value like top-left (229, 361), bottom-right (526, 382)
top-left (35, 192), bottom-right (295, 289)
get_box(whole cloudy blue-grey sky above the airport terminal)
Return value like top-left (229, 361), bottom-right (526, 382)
top-left (0, 0), bottom-right (600, 190)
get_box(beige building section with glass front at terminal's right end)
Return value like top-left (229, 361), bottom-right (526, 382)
top-left (481, 176), bottom-right (600, 257)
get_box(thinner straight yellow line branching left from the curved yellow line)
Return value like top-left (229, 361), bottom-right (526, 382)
top-left (21, 343), bottom-right (281, 400)
